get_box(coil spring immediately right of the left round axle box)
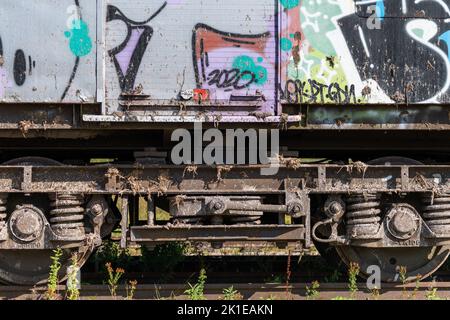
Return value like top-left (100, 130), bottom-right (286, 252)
top-left (50, 194), bottom-right (84, 231)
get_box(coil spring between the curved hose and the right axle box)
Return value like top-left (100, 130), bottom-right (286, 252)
top-left (346, 194), bottom-right (381, 238)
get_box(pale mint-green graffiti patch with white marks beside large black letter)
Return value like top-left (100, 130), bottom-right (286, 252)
top-left (300, 1), bottom-right (342, 56)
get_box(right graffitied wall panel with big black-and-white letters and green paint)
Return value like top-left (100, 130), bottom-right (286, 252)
top-left (280, 0), bottom-right (450, 103)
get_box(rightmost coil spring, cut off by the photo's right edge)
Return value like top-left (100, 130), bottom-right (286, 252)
top-left (423, 194), bottom-right (450, 234)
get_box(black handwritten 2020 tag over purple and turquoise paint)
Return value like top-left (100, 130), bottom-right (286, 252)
top-left (208, 69), bottom-right (256, 90)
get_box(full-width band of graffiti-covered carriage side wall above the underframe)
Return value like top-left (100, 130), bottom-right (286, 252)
top-left (0, 0), bottom-right (450, 110)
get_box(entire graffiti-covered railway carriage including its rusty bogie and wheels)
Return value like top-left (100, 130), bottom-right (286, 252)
top-left (0, 0), bottom-right (450, 284)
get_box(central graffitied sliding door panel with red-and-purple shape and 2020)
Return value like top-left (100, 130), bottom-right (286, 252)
top-left (105, 0), bottom-right (278, 113)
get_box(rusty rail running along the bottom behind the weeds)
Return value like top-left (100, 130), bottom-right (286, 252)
top-left (5, 282), bottom-right (450, 301)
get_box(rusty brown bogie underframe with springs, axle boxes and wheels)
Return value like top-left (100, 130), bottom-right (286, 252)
top-left (0, 164), bottom-right (450, 284)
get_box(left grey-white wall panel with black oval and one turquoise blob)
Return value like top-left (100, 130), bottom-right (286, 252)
top-left (0, 0), bottom-right (96, 103)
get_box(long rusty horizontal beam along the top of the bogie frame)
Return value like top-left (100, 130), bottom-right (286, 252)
top-left (0, 164), bottom-right (444, 195)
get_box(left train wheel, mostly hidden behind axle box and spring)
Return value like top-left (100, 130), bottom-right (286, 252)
top-left (0, 157), bottom-right (94, 285)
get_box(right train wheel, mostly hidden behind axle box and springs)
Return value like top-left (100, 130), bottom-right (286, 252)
top-left (336, 157), bottom-right (450, 282)
